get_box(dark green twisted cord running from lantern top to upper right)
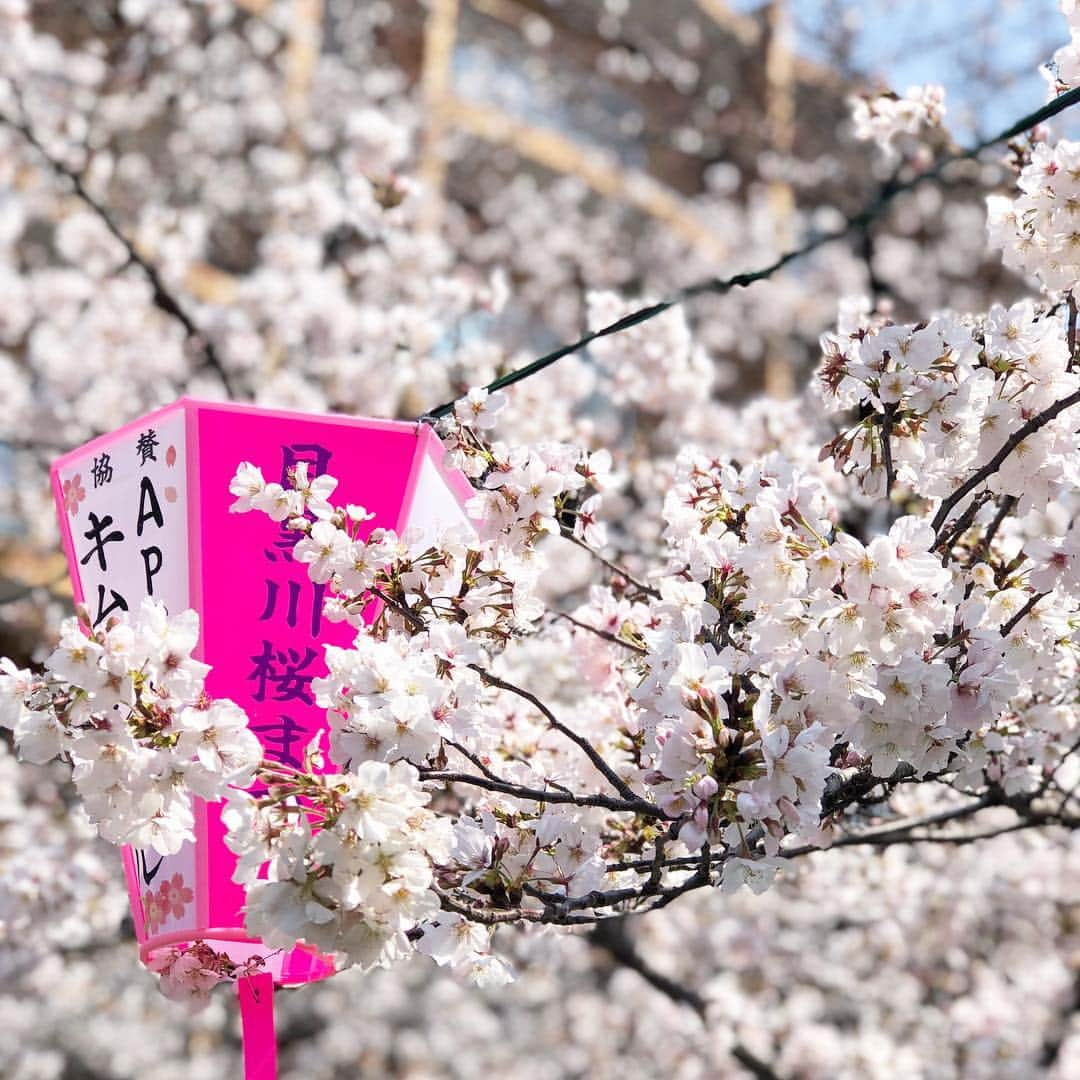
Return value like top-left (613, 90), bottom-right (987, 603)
top-left (419, 86), bottom-right (1080, 422)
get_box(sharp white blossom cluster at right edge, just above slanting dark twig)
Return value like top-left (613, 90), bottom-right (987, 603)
top-left (818, 300), bottom-right (1080, 513)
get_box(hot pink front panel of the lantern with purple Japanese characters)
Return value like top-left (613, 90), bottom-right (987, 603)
top-left (195, 407), bottom-right (419, 927)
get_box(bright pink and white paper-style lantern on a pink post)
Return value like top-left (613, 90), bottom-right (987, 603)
top-left (52, 399), bottom-right (471, 1076)
